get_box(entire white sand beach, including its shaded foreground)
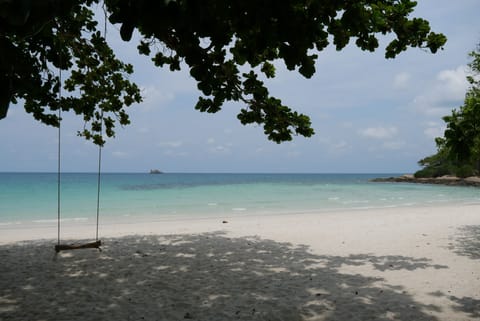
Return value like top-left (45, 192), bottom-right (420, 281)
top-left (0, 205), bottom-right (480, 321)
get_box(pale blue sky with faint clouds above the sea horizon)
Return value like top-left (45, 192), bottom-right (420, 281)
top-left (0, 0), bottom-right (480, 173)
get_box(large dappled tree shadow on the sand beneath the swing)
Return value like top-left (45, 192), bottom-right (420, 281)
top-left (0, 232), bottom-right (445, 321)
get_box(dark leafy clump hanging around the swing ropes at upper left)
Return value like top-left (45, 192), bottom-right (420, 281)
top-left (0, 0), bottom-right (141, 145)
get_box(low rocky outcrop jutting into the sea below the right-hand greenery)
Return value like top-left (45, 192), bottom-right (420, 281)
top-left (372, 175), bottom-right (480, 187)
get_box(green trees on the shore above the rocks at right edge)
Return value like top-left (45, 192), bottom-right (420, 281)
top-left (415, 44), bottom-right (480, 178)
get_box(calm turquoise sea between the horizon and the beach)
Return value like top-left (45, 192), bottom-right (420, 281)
top-left (0, 173), bottom-right (480, 226)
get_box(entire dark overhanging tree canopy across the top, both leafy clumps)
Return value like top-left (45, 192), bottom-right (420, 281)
top-left (0, 0), bottom-right (446, 144)
